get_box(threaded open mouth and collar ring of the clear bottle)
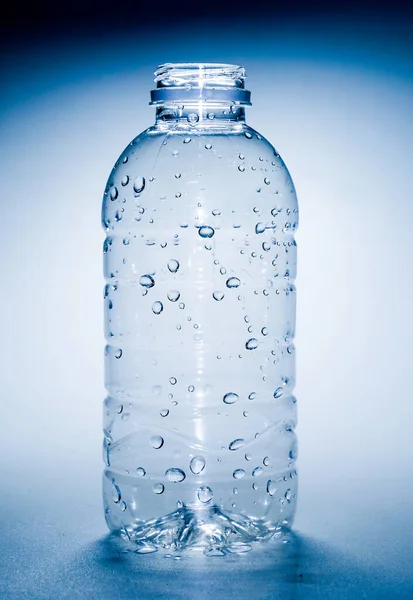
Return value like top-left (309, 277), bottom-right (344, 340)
top-left (150, 63), bottom-right (251, 106)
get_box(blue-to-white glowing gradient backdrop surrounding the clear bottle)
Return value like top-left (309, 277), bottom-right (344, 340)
top-left (0, 10), bottom-right (413, 600)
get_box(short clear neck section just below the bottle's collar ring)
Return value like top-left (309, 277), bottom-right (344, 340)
top-left (156, 100), bottom-right (245, 127)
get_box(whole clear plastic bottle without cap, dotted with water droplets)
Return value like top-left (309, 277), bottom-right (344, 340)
top-left (102, 64), bottom-right (298, 555)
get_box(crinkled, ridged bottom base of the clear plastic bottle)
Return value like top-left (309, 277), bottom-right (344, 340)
top-left (108, 506), bottom-right (292, 556)
